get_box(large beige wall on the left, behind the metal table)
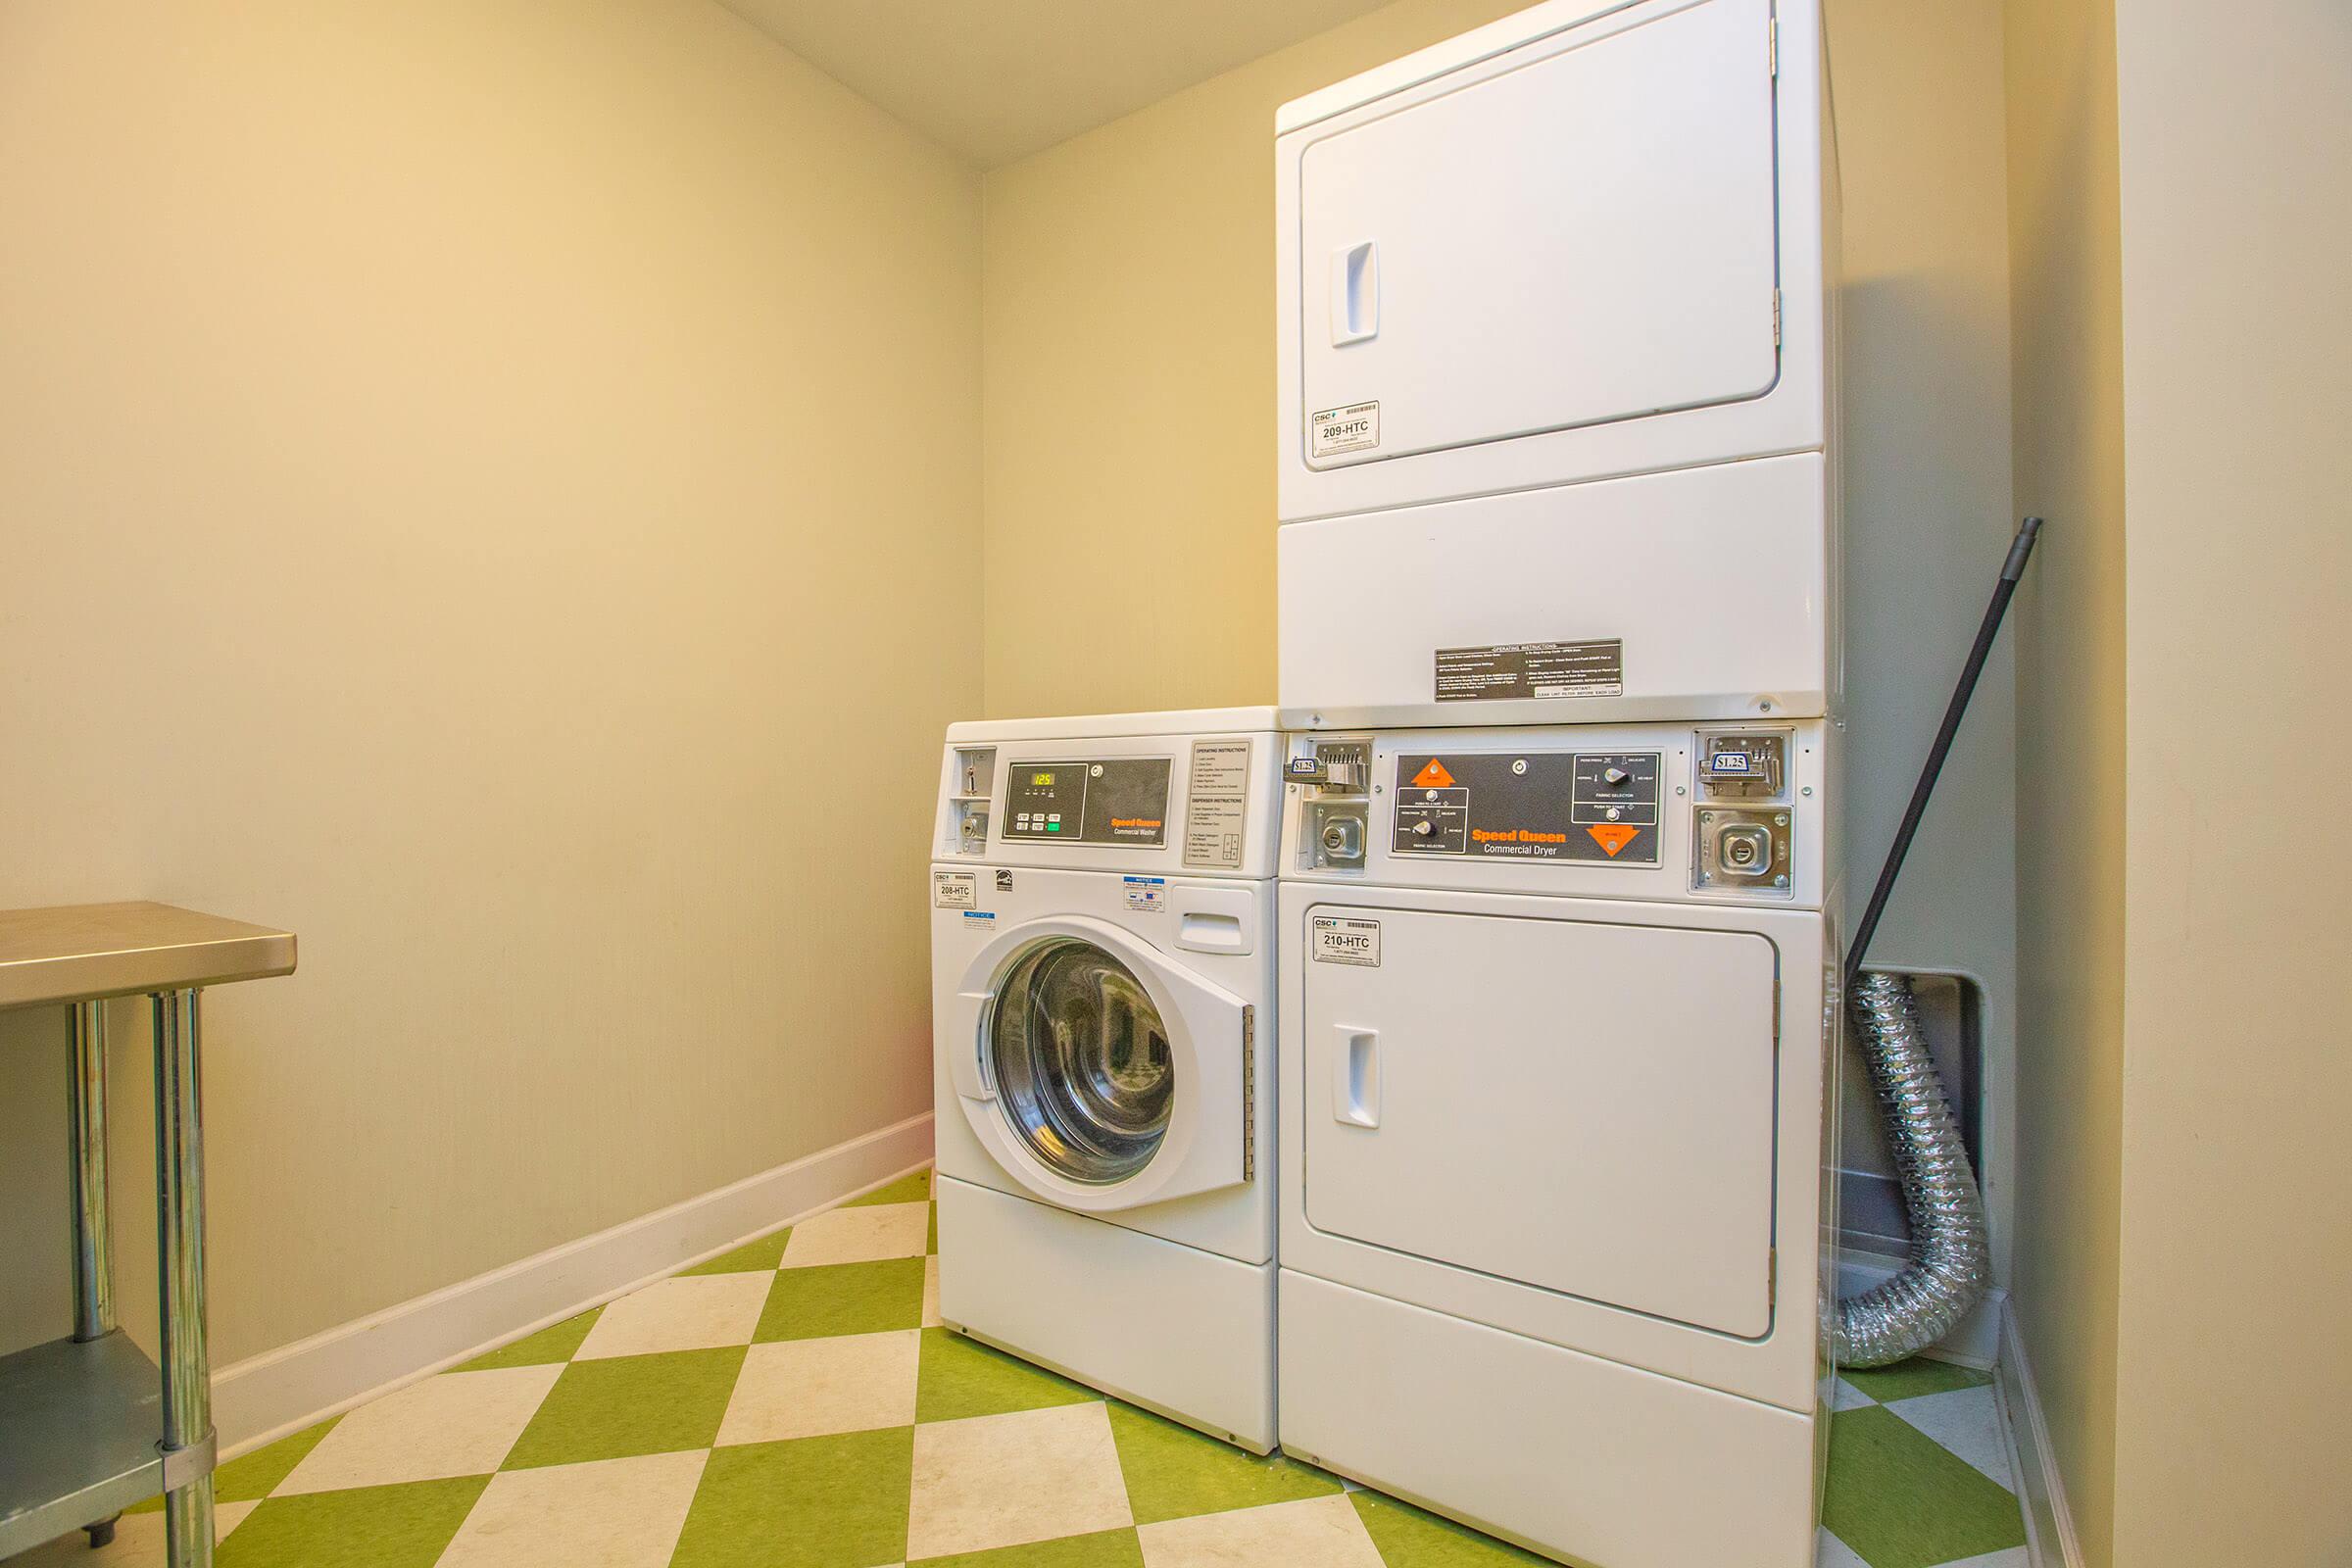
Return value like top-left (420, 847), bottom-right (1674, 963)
top-left (0, 0), bottom-right (981, 1363)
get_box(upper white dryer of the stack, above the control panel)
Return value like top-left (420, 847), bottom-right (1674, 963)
top-left (1275, 0), bottom-right (1839, 729)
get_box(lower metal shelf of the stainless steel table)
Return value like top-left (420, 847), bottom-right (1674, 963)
top-left (0, 1331), bottom-right (212, 1556)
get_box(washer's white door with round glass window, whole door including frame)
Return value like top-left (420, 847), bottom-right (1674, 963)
top-left (951, 917), bottom-right (1256, 1210)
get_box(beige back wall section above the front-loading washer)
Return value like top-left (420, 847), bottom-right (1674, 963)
top-left (983, 0), bottom-right (1524, 714)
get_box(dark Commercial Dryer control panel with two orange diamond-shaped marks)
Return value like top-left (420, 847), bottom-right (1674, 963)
top-left (1390, 750), bottom-right (1663, 865)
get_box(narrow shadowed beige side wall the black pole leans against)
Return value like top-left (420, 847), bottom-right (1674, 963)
top-left (2006, 0), bottom-right (2135, 1568)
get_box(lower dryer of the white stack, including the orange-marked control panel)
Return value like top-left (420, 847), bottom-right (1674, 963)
top-left (1277, 719), bottom-right (1837, 1568)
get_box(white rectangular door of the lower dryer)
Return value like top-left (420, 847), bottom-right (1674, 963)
top-left (1300, 907), bottom-right (1778, 1338)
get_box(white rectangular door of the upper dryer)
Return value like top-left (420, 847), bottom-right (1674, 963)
top-left (1294, 0), bottom-right (1781, 467)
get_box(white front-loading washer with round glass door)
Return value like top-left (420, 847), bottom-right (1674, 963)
top-left (931, 708), bottom-right (1282, 1452)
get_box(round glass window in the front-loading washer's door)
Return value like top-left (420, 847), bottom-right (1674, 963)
top-left (983, 936), bottom-right (1176, 1187)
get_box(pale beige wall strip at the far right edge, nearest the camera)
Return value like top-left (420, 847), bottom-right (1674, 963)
top-left (2115, 0), bottom-right (2352, 1568)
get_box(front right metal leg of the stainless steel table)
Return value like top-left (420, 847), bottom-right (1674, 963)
top-left (153, 990), bottom-right (212, 1568)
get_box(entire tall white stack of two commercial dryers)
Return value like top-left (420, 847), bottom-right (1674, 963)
top-left (1277, 0), bottom-right (1839, 1568)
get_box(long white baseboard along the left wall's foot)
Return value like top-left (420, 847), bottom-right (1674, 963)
top-left (212, 1112), bottom-right (931, 1457)
